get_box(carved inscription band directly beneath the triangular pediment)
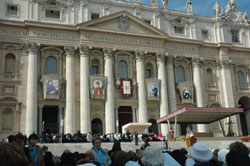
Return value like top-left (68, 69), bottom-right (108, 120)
top-left (81, 33), bottom-right (163, 47)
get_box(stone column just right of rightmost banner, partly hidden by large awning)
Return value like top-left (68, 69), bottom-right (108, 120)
top-left (192, 58), bottom-right (209, 132)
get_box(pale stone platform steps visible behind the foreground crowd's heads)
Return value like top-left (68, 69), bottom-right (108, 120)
top-left (39, 137), bottom-right (250, 156)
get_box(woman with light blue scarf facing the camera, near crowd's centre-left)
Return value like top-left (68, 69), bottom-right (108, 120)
top-left (91, 137), bottom-right (112, 166)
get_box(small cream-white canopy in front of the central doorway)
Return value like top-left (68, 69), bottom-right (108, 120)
top-left (122, 123), bottom-right (152, 133)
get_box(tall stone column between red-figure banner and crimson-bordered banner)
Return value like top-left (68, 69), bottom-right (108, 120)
top-left (103, 48), bottom-right (115, 134)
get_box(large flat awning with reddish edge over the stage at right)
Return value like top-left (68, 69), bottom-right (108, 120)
top-left (157, 107), bottom-right (243, 124)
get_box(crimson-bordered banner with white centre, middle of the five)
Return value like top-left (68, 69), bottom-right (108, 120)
top-left (121, 78), bottom-right (133, 97)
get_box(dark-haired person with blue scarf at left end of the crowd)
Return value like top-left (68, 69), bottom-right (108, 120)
top-left (29, 134), bottom-right (44, 166)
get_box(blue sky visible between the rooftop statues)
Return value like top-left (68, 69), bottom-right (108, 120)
top-left (141, 0), bottom-right (250, 16)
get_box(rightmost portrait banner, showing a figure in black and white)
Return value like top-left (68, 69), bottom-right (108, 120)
top-left (179, 82), bottom-right (194, 103)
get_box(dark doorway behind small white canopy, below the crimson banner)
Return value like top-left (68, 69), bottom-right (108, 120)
top-left (118, 106), bottom-right (133, 133)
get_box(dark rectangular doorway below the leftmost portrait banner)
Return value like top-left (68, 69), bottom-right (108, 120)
top-left (42, 106), bottom-right (59, 134)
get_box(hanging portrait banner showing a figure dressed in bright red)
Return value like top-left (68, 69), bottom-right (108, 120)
top-left (89, 76), bottom-right (106, 99)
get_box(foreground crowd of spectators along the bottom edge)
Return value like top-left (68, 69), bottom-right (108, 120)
top-left (0, 133), bottom-right (250, 166)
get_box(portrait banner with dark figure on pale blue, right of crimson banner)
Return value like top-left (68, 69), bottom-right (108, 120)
top-left (146, 79), bottom-right (160, 101)
